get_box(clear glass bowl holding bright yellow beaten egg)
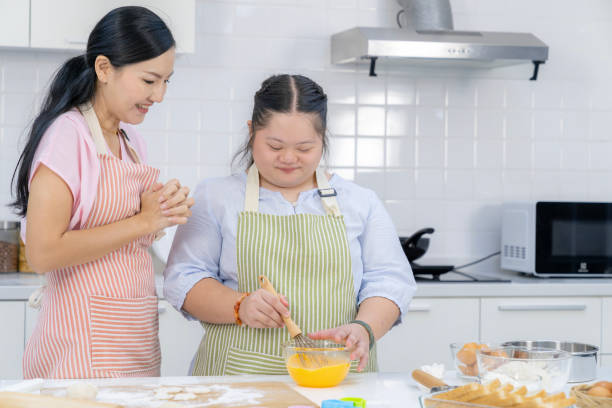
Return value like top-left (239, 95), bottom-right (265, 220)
top-left (283, 340), bottom-right (351, 388)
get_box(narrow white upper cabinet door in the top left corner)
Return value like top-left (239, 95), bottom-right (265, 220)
top-left (0, 0), bottom-right (30, 47)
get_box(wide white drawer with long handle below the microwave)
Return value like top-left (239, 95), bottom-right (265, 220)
top-left (480, 298), bottom-right (601, 345)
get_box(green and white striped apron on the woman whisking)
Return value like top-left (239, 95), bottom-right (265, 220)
top-left (192, 165), bottom-right (377, 375)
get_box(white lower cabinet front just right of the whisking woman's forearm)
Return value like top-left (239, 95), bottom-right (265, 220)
top-left (377, 298), bottom-right (480, 372)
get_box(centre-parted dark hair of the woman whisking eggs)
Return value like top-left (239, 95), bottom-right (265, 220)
top-left (232, 74), bottom-right (329, 167)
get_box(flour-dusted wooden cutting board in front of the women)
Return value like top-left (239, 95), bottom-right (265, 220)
top-left (41, 381), bottom-right (319, 408)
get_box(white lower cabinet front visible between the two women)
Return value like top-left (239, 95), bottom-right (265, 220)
top-left (159, 300), bottom-right (204, 376)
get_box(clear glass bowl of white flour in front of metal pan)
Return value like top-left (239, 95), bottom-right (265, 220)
top-left (476, 346), bottom-right (572, 393)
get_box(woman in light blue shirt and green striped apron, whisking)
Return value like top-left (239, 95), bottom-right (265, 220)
top-left (164, 75), bottom-right (416, 375)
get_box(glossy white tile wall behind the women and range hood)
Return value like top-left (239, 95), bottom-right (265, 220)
top-left (0, 0), bottom-right (612, 257)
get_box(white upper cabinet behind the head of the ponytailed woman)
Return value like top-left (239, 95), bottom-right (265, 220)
top-left (30, 0), bottom-right (195, 53)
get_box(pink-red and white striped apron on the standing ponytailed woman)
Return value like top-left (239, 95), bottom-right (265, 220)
top-left (23, 104), bottom-right (161, 378)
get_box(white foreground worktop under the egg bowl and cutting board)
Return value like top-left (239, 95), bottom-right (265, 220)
top-left (0, 367), bottom-right (612, 408)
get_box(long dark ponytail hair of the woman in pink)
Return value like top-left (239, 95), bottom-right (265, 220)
top-left (11, 6), bottom-right (175, 217)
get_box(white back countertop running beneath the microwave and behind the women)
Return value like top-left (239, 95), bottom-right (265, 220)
top-left (0, 271), bottom-right (612, 301)
